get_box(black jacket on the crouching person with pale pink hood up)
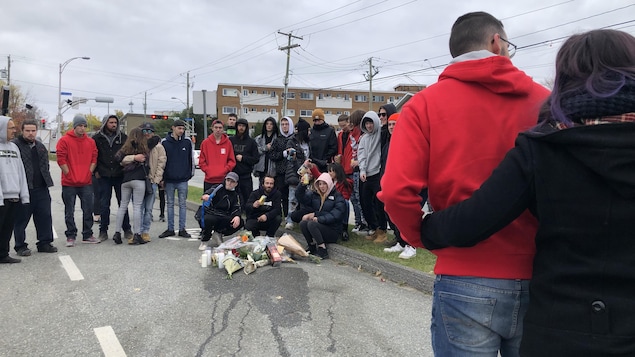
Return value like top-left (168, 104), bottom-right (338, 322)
top-left (295, 185), bottom-right (346, 235)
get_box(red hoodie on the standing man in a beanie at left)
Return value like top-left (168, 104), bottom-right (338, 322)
top-left (56, 129), bottom-right (97, 187)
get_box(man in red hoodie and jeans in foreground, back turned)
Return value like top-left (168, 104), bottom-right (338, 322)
top-left (379, 12), bottom-right (549, 357)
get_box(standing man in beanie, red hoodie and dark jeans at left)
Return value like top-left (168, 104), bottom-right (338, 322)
top-left (56, 114), bottom-right (100, 247)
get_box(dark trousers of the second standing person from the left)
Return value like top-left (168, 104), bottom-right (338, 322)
top-left (13, 187), bottom-right (53, 252)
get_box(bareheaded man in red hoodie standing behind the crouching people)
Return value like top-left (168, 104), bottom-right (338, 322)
top-left (198, 120), bottom-right (236, 191)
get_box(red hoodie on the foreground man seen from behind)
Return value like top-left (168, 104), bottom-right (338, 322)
top-left (378, 56), bottom-right (549, 279)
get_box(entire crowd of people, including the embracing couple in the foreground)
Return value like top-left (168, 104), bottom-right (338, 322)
top-left (0, 8), bottom-right (635, 357)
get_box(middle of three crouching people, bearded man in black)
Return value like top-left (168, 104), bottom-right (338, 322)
top-left (245, 175), bottom-right (282, 237)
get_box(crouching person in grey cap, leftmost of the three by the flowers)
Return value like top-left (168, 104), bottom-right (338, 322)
top-left (198, 172), bottom-right (244, 250)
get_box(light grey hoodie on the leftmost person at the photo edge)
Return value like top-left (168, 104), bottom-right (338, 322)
top-left (0, 116), bottom-right (29, 206)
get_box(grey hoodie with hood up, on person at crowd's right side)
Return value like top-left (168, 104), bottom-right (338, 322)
top-left (357, 110), bottom-right (381, 176)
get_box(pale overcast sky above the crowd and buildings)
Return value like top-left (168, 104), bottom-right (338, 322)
top-left (0, 0), bottom-right (635, 121)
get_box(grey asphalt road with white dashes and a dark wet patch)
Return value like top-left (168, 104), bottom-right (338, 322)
top-left (0, 163), bottom-right (432, 357)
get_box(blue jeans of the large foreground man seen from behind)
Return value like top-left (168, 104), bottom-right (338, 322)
top-left (430, 275), bottom-right (529, 357)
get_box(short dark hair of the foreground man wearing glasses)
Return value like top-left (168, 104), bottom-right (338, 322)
top-left (450, 11), bottom-right (505, 58)
